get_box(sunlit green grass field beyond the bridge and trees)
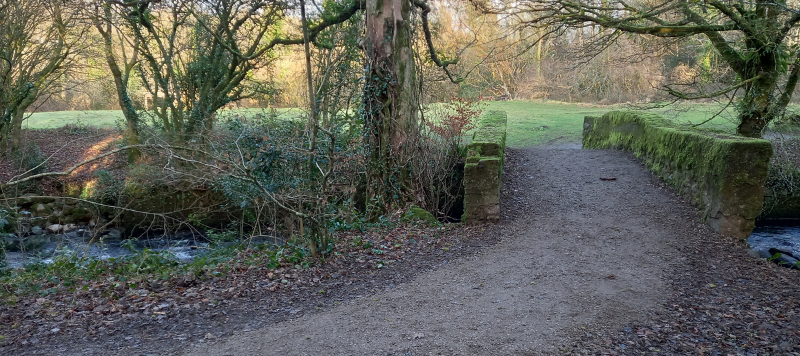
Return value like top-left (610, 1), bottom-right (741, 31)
top-left (25, 101), bottom-right (736, 147)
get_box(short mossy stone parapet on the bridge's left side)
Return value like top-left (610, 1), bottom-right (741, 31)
top-left (462, 111), bottom-right (507, 224)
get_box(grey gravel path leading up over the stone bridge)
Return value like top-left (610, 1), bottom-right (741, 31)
top-left (185, 149), bottom-right (714, 355)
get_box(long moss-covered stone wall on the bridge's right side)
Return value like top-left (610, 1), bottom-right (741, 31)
top-left (583, 111), bottom-right (772, 239)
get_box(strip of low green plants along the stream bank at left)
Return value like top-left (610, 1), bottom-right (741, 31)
top-left (0, 215), bottom-right (438, 300)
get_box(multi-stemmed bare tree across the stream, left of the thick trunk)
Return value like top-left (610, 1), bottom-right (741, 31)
top-left (107, 0), bottom-right (364, 140)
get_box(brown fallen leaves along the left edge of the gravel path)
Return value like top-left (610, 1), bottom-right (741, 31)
top-left (0, 221), bottom-right (494, 353)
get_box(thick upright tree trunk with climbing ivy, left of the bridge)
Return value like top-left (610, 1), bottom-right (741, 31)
top-left (364, 0), bottom-right (419, 215)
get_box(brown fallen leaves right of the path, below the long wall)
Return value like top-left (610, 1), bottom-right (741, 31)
top-left (572, 224), bottom-right (800, 355)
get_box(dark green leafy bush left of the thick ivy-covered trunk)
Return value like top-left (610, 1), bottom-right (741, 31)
top-left (214, 115), bottom-right (361, 251)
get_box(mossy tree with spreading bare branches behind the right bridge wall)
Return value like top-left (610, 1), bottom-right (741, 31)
top-left (473, 0), bottom-right (800, 137)
